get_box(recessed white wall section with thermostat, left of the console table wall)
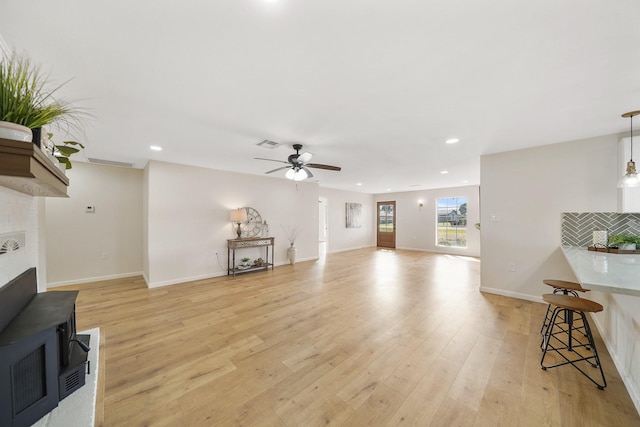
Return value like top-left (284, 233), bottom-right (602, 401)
top-left (45, 162), bottom-right (142, 286)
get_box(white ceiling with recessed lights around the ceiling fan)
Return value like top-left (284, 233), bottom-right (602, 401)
top-left (0, 0), bottom-right (640, 193)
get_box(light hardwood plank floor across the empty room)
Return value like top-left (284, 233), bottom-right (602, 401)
top-left (58, 248), bottom-right (640, 427)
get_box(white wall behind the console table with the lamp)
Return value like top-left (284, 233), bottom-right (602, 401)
top-left (145, 161), bottom-right (319, 287)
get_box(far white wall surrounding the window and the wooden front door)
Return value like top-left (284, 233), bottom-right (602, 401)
top-left (373, 186), bottom-right (480, 256)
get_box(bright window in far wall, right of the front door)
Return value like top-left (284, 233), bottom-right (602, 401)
top-left (436, 197), bottom-right (467, 248)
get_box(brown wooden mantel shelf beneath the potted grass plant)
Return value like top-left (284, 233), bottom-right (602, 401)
top-left (0, 138), bottom-right (69, 197)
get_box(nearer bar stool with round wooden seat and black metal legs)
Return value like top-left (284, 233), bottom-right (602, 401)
top-left (540, 294), bottom-right (607, 390)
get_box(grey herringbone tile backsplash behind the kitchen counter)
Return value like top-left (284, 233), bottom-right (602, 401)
top-left (562, 212), bottom-right (640, 247)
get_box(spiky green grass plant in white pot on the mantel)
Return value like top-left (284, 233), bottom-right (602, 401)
top-left (0, 52), bottom-right (84, 129)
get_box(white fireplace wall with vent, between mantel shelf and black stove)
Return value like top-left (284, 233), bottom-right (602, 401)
top-left (0, 186), bottom-right (46, 291)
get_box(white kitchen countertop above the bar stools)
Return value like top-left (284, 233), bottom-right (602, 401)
top-left (562, 247), bottom-right (640, 296)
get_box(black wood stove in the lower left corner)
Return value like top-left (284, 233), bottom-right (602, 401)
top-left (0, 268), bottom-right (89, 427)
